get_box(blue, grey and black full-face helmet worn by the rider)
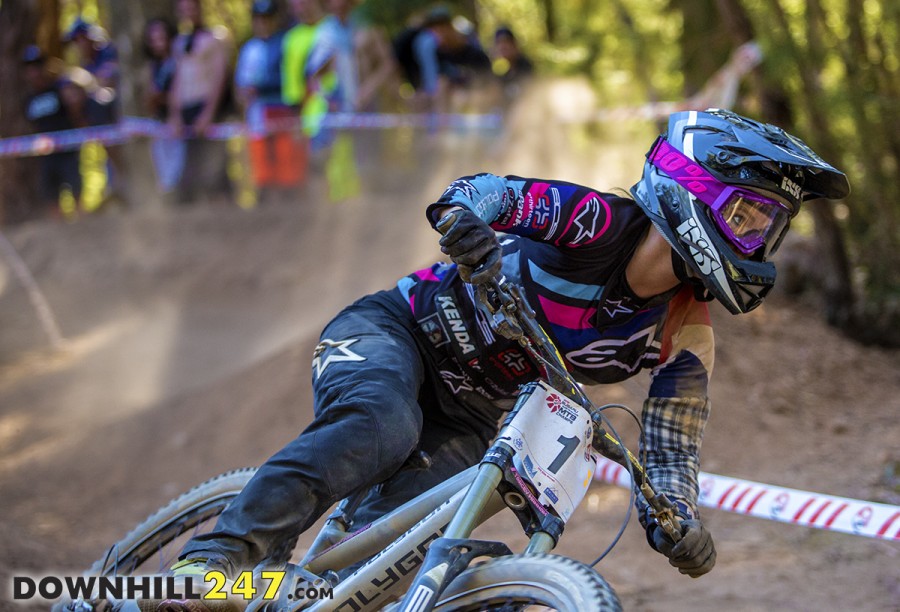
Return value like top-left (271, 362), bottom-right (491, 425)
top-left (631, 109), bottom-right (850, 314)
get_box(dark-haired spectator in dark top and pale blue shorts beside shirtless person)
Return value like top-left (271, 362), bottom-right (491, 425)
top-left (143, 18), bottom-right (185, 194)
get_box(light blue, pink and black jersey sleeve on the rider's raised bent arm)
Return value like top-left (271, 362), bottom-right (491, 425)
top-left (428, 174), bottom-right (615, 249)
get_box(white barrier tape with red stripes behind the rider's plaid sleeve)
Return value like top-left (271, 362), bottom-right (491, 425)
top-left (594, 457), bottom-right (900, 542)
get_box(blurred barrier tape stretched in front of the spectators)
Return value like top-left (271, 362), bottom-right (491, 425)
top-left (0, 113), bottom-right (501, 158)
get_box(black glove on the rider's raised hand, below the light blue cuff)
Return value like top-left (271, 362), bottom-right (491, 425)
top-left (435, 209), bottom-right (503, 285)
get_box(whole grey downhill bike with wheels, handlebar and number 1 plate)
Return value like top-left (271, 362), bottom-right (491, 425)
top-left (78, 277), bottom-right (680, 612)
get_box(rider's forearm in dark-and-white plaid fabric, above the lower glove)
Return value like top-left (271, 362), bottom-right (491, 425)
top-left (638, 397), bottom-right (709, 522)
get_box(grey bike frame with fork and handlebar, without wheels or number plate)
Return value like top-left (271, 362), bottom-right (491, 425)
top-left (247, 280), bottom-right (680, 612)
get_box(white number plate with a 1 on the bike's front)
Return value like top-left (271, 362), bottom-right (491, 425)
top-left (500, 382), bottom-right (597, 521)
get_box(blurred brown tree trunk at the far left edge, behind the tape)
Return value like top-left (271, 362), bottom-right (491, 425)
top-left (0, 0), bottom-right (39, 224)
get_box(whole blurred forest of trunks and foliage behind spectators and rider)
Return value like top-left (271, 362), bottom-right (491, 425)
top-left (0, 0), bottom-right (900, 346)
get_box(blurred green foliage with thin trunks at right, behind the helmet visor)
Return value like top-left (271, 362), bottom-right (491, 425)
top-left (745, 0), bottom-right (900, 334)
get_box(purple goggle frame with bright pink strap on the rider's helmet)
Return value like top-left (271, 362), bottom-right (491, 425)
top-left (647, 138), bottom-right (791, 255)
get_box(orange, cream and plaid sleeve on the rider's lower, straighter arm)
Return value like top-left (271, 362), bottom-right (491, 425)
top-left (638, 287), bottom-right (714, 522)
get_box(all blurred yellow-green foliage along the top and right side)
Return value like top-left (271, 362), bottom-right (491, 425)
top-left (24, 0), bottom-right (900, 334)
